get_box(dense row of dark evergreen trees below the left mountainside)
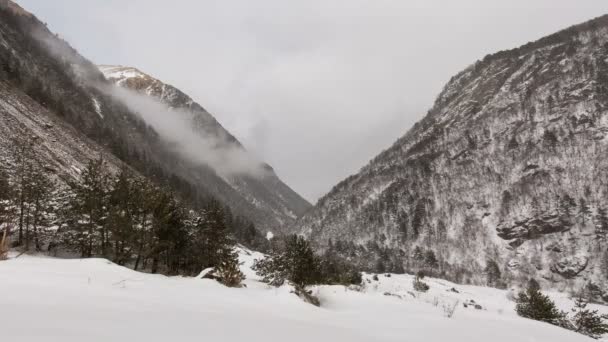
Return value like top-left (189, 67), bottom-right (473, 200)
top-left (0, 141), bottom-right (264, 282)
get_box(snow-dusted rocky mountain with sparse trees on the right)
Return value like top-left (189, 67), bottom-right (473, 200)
top-left (295, 16), bottom-right (608, 299)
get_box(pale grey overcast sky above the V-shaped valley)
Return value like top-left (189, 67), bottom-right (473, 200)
top-left (16, 0), bottom-right (608, 203)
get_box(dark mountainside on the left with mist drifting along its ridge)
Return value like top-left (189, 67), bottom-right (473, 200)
top-left (0, 0), bottom-right (309, 234)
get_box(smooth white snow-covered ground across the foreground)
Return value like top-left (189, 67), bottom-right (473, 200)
top-left (0, 250), bottom-right (608, 342)
